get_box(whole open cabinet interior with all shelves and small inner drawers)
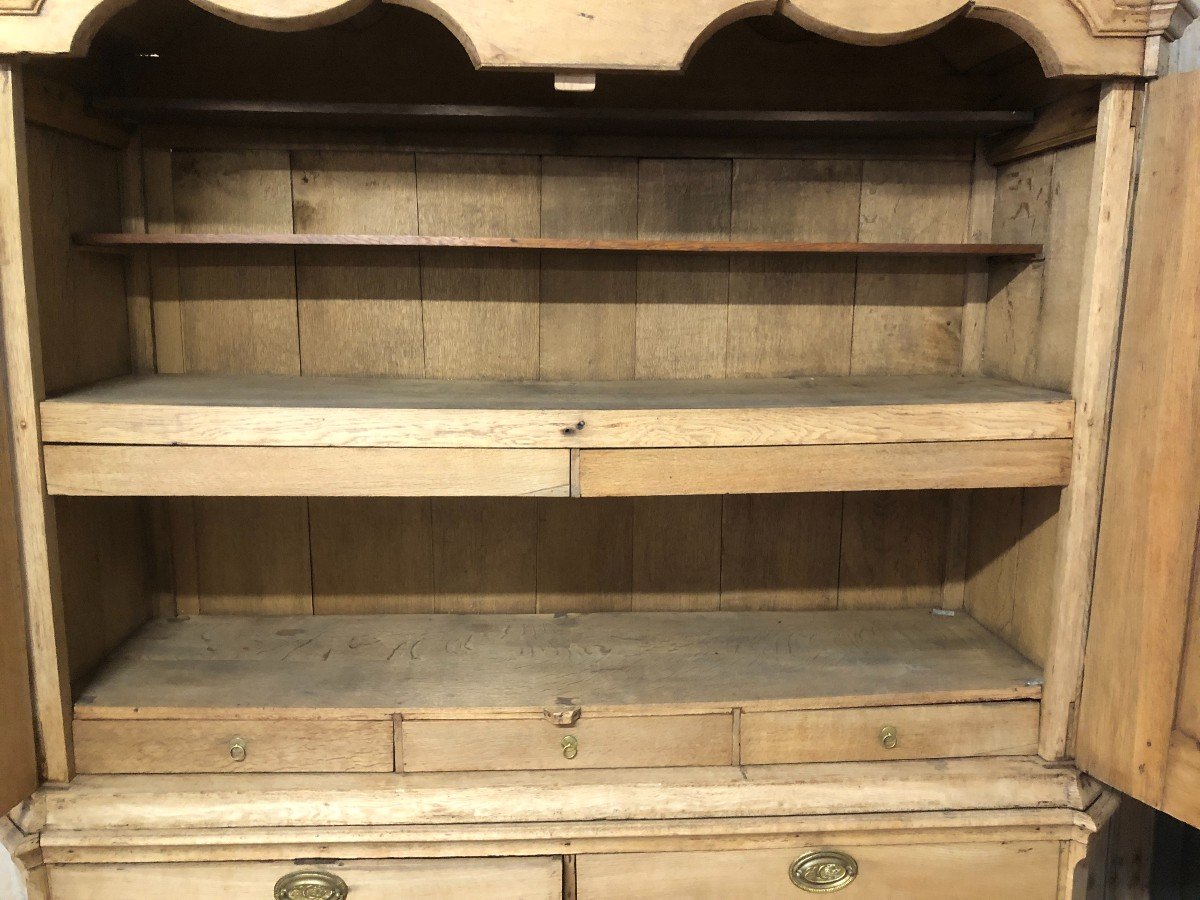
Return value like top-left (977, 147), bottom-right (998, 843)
top-left (18, 2), bottom-right (1108, 774)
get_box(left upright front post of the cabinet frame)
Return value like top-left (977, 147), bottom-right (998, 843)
top-left (0, 62), bottom-right (72, 781)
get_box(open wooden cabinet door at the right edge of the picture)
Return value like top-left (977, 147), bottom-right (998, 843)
top-left (1076, 73), bottom-right (1200, 824)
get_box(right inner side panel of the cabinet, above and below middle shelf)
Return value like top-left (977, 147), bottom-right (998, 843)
top-left (965, 127), bottom-right (1096, 664)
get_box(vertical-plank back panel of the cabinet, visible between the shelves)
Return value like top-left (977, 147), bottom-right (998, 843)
top-left (133, 150), bottom-right (1012, 613)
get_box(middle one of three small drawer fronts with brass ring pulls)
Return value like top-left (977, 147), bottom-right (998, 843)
top-left (396, 714), bottom-right (733, 772)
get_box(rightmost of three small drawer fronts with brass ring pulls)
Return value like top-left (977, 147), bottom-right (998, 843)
top-left (742, 701), bottom-right (1040, 766)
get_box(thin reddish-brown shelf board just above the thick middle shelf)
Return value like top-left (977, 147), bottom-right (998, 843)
top-left (74, 233), bottom-right (1042, 257)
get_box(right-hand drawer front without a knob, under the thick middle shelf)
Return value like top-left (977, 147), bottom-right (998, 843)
top-left (580, 440), bottom-right (1072, 497)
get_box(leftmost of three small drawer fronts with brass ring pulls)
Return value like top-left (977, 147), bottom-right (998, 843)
top-left (74, 719), bottom-right (395, 775)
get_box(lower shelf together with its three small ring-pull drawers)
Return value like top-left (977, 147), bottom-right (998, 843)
top-left (76, 611), bottom-right (1040, 773)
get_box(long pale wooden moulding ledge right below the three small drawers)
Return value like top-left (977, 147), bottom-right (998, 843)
top-left (31, 756), bottom-right (1098, 845)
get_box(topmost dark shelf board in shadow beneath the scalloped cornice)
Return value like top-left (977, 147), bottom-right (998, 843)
top-left (95, 97), bottom-right (1034, 138)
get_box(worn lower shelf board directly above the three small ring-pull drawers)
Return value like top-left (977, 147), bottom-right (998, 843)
top-left (76, 610), bottom-right (1040, 720)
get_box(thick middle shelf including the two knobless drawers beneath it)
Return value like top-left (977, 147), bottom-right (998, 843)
top-left (41, 374), bottom-right (1075, 497)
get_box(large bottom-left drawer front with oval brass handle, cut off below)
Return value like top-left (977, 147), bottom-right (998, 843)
top-left (50, 857), bottom-right (563, 900)
